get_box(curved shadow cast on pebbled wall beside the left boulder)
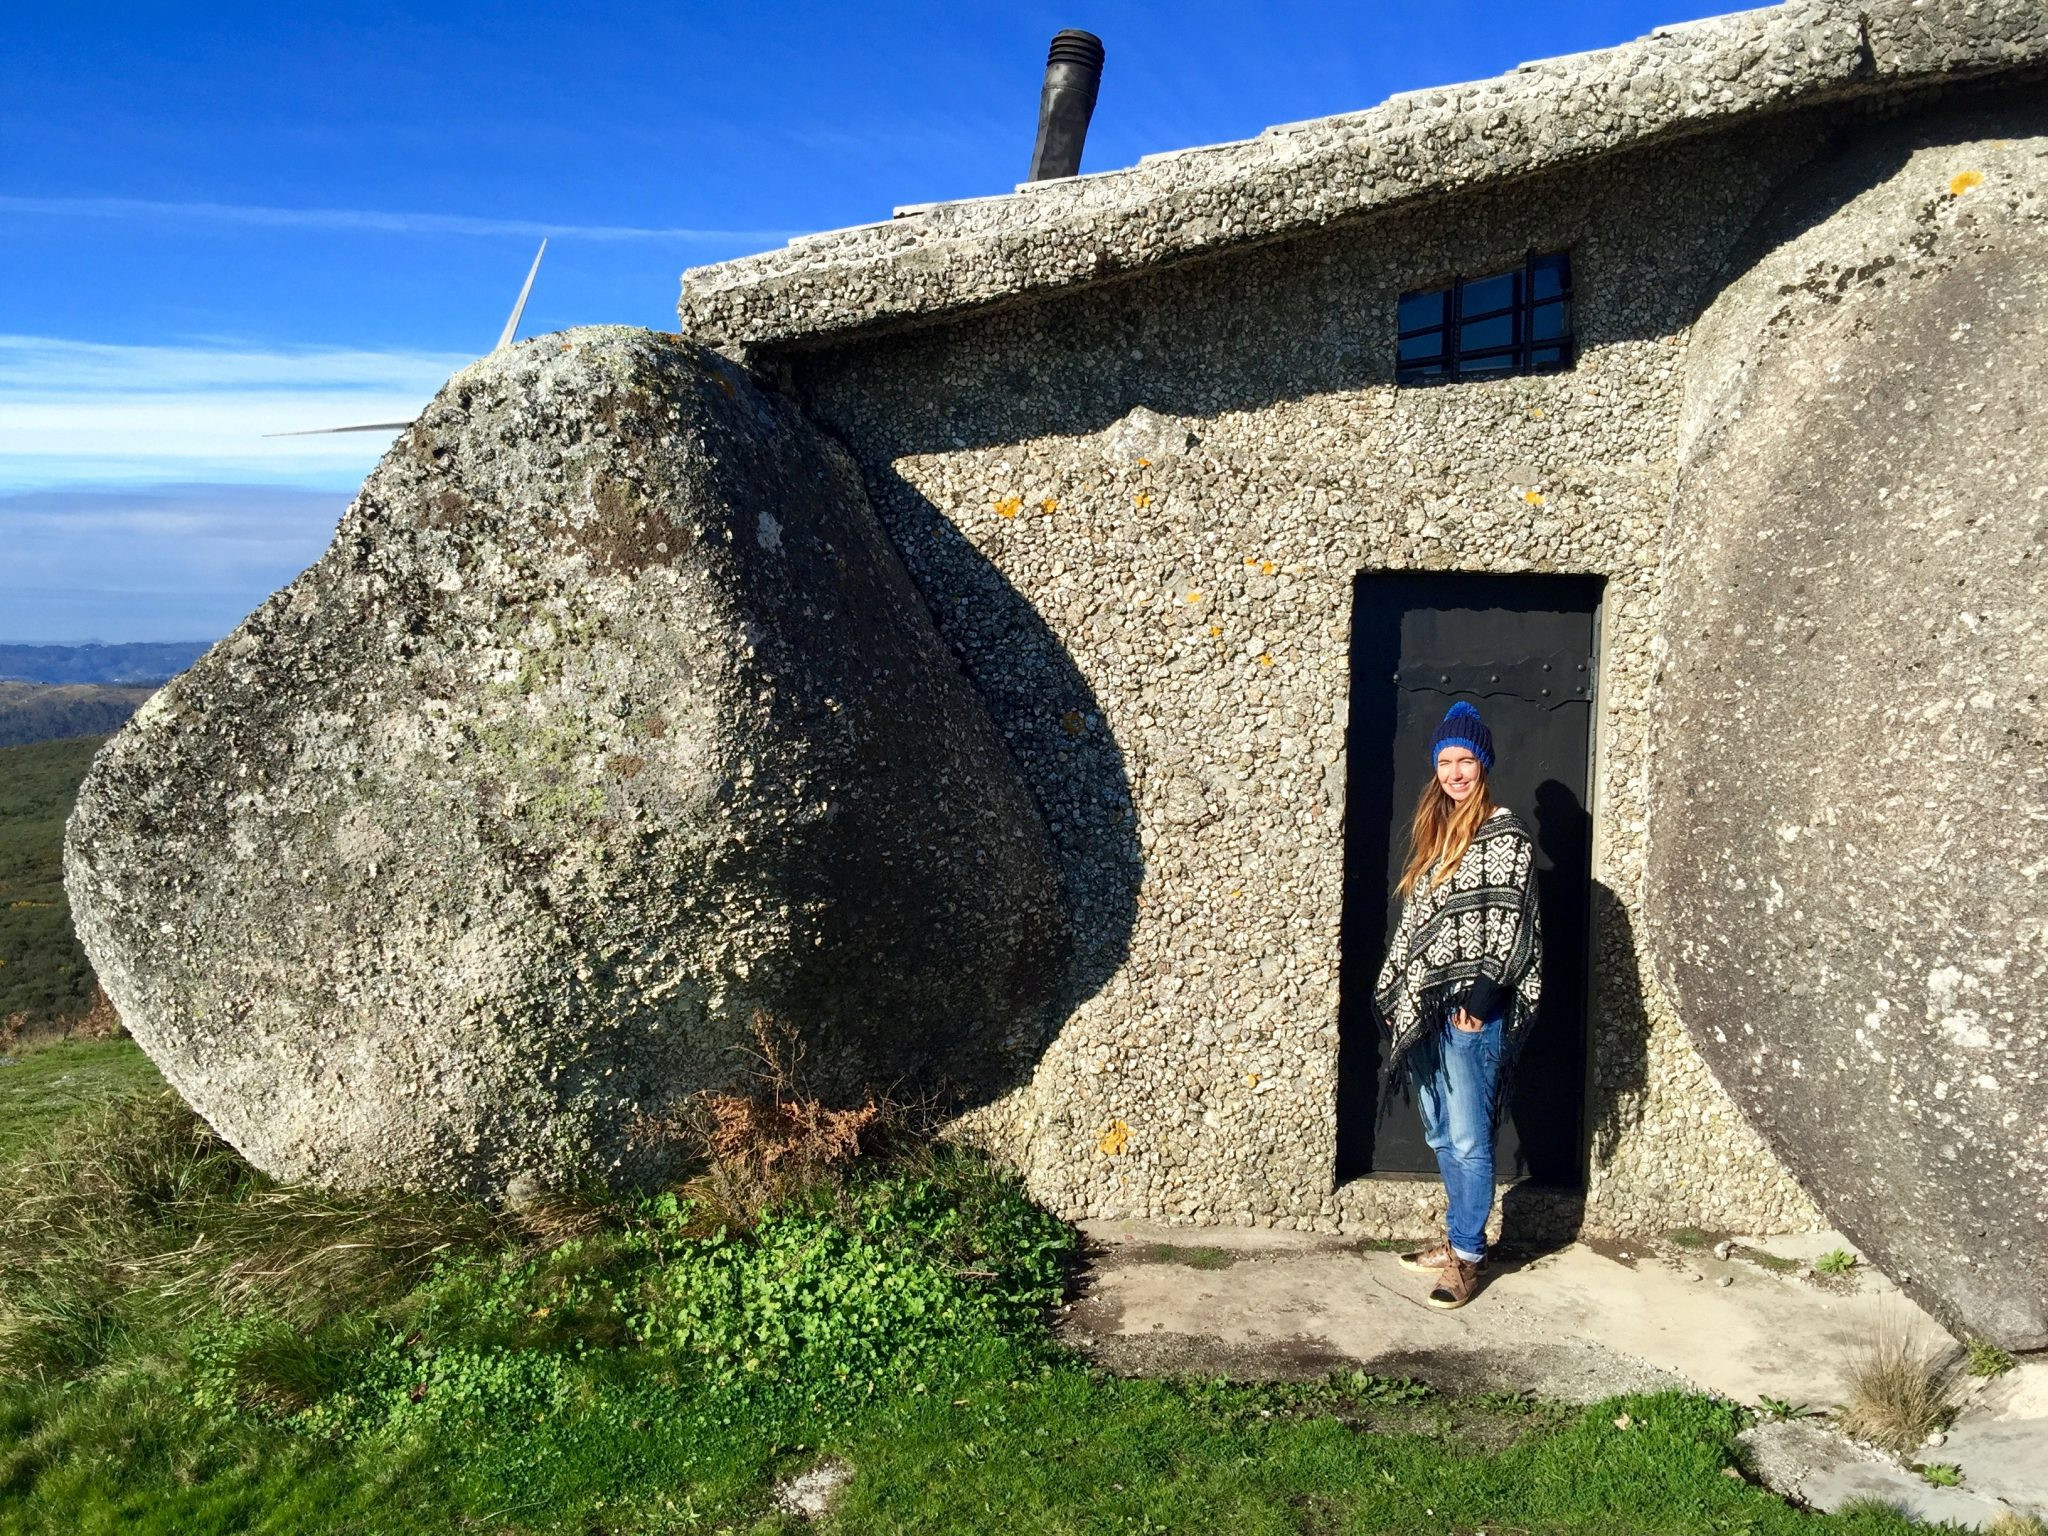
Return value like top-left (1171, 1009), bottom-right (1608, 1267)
top-left (868, 467), bottom-right (1145, 1028)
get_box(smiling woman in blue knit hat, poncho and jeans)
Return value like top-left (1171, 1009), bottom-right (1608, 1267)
top-left (1374, 702), bottom-right (1542, 1307)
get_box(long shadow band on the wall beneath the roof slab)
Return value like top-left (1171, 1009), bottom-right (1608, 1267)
top-left (788, 109), bottom-right (1875, 457)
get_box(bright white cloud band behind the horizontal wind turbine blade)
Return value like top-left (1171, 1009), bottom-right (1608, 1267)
top-left (0, 336), bottom-right (473, 489)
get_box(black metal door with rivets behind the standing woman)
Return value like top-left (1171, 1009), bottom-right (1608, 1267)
top-left (1337, 571), bottom-right (1599, 1188)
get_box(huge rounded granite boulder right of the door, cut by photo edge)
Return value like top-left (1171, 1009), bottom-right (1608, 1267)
top-left (1647, 102), bottom-right (2048, 1350)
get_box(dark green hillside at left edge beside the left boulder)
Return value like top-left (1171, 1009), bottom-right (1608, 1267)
top-left (0, 735), bottom-right (106, 1038)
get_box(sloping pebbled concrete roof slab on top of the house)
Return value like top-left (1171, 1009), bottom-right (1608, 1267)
top-left (680, 0), bottom-right (2048, 348)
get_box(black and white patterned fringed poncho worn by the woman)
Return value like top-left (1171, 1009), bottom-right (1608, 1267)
top-left (1372, 811), bottom-right (1542, 1098)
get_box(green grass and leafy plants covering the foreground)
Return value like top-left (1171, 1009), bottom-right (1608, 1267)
top-left (0, 1042), bottom-right (1949, 1536)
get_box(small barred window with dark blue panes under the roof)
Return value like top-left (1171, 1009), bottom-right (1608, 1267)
top-left (1395, 252), bottom-right (1571, 383)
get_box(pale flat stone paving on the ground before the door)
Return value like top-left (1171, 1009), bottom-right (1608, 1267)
top-left (1061, 1221), bottom-right (2048, 1526)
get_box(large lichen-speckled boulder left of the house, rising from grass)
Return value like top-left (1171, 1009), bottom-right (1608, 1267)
top-left (66, 328), bottom-right (1069, 1194)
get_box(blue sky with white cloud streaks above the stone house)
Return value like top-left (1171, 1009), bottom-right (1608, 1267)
top-left (0, 0), bottom-right (1729, 643)
